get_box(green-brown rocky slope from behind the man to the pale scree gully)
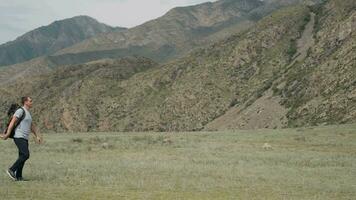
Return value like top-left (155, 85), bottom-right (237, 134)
top-left (2, 3), bottom-right (309, 131)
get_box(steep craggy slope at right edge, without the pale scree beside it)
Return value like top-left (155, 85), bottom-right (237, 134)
top-left (275, 0), bottom-right (356, 126)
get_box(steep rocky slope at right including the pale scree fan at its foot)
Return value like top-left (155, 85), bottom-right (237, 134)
top-left (207, 0), bottom-right (356, 130)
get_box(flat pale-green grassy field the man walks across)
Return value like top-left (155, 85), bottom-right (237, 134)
top-left (0, 125), bottom-right (356, 200)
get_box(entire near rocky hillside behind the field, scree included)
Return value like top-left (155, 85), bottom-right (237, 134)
top-left (0, 0), bottom-right (356, 132)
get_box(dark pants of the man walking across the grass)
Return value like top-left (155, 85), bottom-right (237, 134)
top-left (10, 138), bottom-right (30, 178)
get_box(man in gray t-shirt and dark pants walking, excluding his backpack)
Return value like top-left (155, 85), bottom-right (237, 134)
top-left (0, 97), bottom-right (42, 181)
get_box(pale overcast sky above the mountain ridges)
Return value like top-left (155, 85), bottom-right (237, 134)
top-left (0, 0), bottom-right (214, 44)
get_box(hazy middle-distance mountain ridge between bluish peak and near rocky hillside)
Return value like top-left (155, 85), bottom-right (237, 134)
top-left (51, 0), bottom-right (312, 65)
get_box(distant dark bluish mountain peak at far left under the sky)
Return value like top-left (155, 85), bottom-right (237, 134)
top-left (0, 16), bottom-right (124, 66)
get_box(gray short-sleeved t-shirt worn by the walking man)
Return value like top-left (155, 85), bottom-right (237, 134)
top-left (14, 107), bottom-right (32, 140)
